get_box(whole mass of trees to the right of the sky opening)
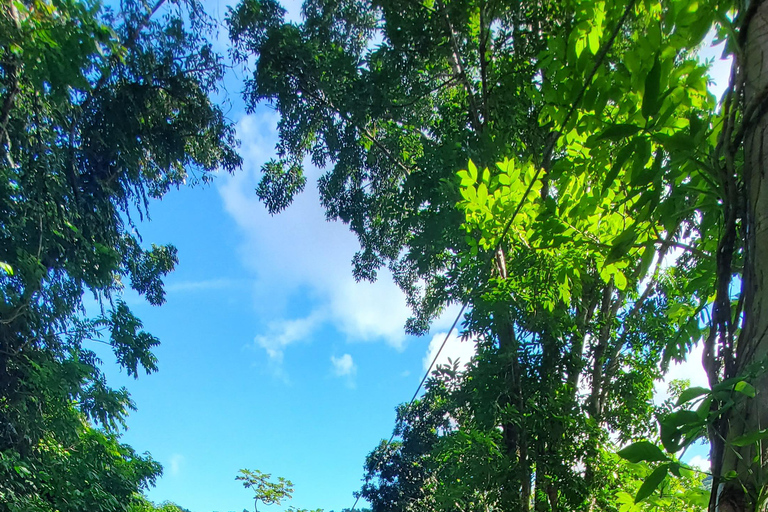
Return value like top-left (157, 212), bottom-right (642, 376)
top-left (229, 0), bottom-right (766, 510)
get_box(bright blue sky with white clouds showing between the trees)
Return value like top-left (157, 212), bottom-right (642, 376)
top-left (96, 2), bottom-right (723, 512)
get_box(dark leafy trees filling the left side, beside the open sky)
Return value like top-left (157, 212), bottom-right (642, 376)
top-left (0, 0), bottom-right (239, 512)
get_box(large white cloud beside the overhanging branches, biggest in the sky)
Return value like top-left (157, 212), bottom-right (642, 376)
top-left (218, 113), bottom-right (410, 360)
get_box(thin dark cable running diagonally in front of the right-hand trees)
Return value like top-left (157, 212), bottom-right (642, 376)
top-left (350, 0), bottom-right (635, 512)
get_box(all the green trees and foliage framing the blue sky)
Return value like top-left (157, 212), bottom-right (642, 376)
top-left (0, 0), bottom-right (768, 512)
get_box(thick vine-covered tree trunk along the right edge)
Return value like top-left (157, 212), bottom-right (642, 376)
top-left (710, 0), bottom-right (768, 512)
